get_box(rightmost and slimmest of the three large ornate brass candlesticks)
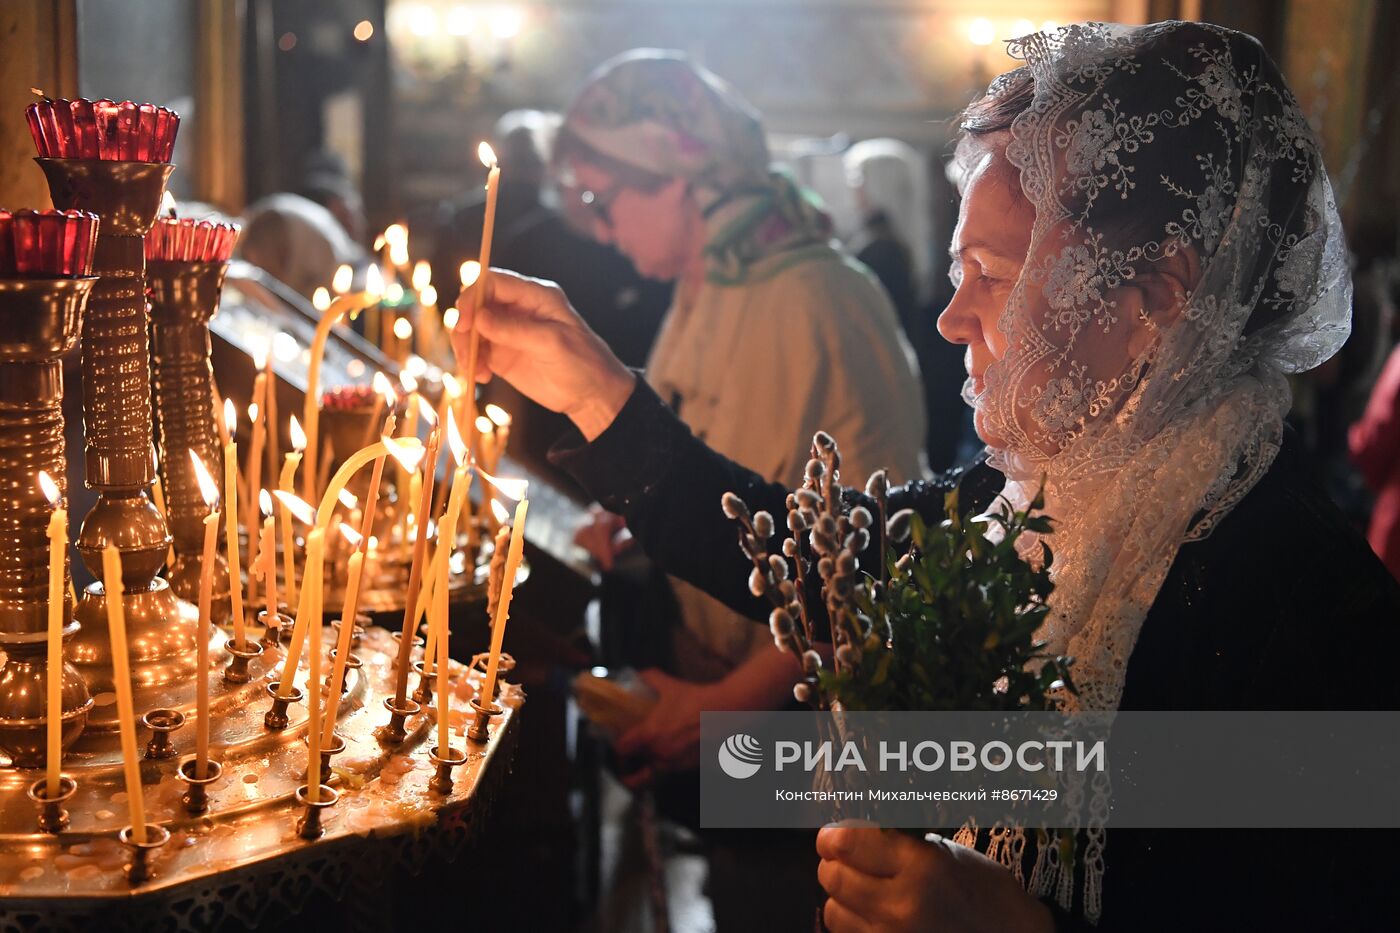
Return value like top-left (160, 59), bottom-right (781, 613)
top-left (146, 261), bottom-right (230, 623)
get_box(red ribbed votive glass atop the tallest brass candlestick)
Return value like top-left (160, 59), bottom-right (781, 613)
top-left (24, 99), bottom-right (179, 163)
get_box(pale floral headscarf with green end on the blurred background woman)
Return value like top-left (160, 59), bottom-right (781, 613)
top-left (560, 49), bottom-right (832, 284)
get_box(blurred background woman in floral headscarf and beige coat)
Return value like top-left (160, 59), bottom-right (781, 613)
top-left (554, 49), bottom-right (924, 776)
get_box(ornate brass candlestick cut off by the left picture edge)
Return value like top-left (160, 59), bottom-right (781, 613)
top-left (0, 279), bottom-right (97, 768)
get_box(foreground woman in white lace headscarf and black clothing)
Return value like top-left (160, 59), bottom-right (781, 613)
top-left (453, 22), bottom-right (1400, 933)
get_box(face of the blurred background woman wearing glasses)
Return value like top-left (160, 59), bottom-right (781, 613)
top-left (571, 161), bottom-right (694, 282)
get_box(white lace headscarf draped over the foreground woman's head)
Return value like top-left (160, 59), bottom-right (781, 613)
top-left (965, 22), bottom-right (1351, 916)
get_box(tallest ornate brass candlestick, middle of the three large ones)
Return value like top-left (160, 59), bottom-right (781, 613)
top-left (36, 158), bottom-right (189, 730)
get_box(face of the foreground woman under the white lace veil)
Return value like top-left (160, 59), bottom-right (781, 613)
top-left (938, 140), bottom-right (1175, 457)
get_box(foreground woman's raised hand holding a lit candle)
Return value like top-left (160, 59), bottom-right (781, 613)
top-left (452, 269), bottom-right (636, 441)
